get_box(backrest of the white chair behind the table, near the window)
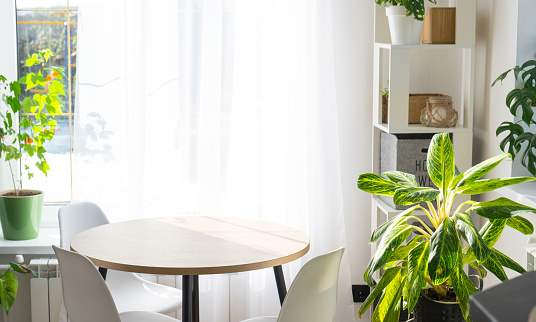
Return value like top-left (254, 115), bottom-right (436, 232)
top-left (58, 202), bottom-right (110, 249)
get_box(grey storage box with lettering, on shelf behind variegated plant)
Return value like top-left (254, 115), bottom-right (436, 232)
top-left (379, 132), bottom-right (435, 210)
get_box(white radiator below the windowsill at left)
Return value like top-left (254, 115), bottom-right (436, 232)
top-left (30, 258), bottom-right (62, 322)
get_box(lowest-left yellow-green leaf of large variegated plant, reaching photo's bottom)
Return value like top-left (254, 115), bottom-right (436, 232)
top-left (372, 271), bottom-right (406, 322)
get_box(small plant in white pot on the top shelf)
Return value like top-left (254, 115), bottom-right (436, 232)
top-left (374, 0), bottom-right (437, 45)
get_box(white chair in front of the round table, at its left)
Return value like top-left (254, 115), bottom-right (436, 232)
top-left (52, 246), bottom-right (177, 322)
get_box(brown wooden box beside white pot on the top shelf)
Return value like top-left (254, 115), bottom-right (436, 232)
top-left (422, 8), bottom-right (456, 44)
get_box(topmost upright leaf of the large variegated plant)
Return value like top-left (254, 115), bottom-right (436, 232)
top-left (426, 133), bottom-right (455, 191)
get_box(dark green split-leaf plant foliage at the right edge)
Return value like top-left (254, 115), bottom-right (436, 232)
top-left (491, 60), bottom-right (536, 176)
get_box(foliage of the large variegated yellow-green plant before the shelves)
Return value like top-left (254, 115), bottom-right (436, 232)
top-left (357, 133), bottom-right (536, 322)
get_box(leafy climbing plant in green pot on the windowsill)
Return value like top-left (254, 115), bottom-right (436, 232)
top-left (0, 49), bottom-right (65, 240)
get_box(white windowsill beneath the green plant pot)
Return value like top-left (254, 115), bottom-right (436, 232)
top-left (0, 227), bottom-right (60, 255)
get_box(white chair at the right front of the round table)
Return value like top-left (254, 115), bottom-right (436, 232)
top-left (243, 248), bottom-right (344, 322)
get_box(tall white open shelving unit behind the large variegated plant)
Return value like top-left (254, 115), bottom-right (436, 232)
top-left (371, 0), bottom-right (476, 262)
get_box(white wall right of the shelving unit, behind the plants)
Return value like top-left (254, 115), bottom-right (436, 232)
top-left (473, 0), bottom-right (536, 288)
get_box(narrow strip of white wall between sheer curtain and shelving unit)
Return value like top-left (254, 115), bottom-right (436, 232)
top-left (332, 0), bottom-right (374, 320)
